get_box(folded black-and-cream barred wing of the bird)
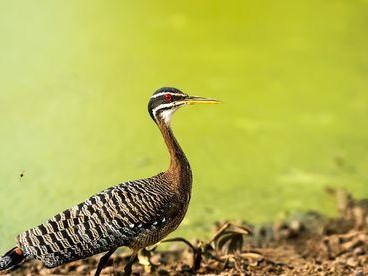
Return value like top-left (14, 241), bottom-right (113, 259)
top-left (18, 178), bottom-right (176, 267)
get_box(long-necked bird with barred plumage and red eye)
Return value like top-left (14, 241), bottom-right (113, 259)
top-left (0, 87), bottom-right (220, 275)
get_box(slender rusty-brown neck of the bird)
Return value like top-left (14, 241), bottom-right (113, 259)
top-left (158, 122), bottom-right (192, 190)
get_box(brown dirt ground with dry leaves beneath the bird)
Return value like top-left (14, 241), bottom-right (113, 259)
top-left (0, 190), bottom-right (368, 276)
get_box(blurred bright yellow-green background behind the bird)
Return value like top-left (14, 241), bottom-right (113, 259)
top-left (0, 0), bottom-right (368, 251)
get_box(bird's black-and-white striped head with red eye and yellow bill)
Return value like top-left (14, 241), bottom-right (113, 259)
top-left (148, 87), bottom-right (220, 125)
